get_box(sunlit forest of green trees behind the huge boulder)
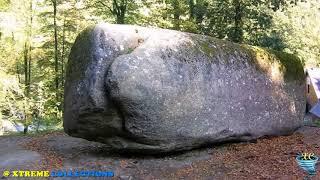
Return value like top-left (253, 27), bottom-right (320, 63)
top-left (0, 0), bottom-right (320, 133)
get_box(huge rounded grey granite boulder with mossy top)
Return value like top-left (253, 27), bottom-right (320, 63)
top-left (64, 24), bottom-right (305, 153)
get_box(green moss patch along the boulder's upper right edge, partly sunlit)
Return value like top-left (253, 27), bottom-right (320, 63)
top-left (189, 36), bottom-right (304, 82)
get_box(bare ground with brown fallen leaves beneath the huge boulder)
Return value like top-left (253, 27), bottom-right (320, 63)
top-left (0, 126), bottom-right (320, 180)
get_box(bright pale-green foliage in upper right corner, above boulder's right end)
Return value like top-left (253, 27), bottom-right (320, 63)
top-left (273, 0), bottom-right (320, 66)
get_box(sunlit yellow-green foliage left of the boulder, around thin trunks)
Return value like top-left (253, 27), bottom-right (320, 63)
top-left (0, 0), bottom-right (88, 133)
